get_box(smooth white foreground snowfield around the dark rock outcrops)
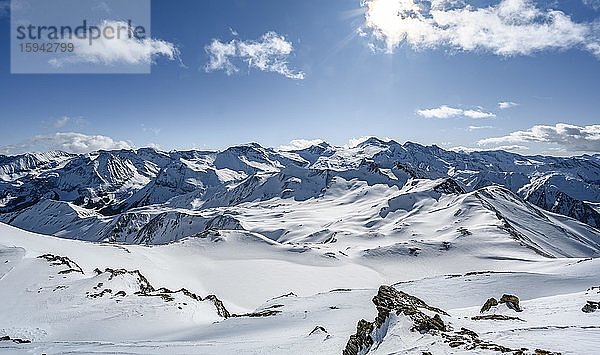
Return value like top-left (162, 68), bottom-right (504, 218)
top-left (0, 225), bottom-right (600, 354)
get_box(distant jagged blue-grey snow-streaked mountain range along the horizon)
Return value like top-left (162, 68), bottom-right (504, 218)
top-left (0, 138), bottom-right (600, 233)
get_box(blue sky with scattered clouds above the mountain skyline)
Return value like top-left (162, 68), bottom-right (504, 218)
top-left (0, 0), bottom-right (600, 155)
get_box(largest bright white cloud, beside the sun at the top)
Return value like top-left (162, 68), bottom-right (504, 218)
top-left (363, 0), bottom-right (600, 56)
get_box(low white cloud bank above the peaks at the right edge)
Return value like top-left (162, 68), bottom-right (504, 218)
top-left (478, 123), bottom-right (600, 152)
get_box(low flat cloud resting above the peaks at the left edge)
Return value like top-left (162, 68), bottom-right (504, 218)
top-left (0, 133), bottom-right (133, 155)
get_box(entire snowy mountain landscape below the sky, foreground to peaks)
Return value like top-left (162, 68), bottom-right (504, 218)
top-left (0, 138), bottom-right (600, 355)
